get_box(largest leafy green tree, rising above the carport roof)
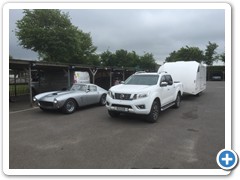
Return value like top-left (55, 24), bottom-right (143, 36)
top-left (15, 9), bottom-right (96, 64)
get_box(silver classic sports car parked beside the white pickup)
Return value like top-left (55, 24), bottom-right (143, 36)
top-left (33, 83), bottom-right (107, 114)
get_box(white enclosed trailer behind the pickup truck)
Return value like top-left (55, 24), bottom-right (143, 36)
top-left (158, 61), bottom-right (207, 95)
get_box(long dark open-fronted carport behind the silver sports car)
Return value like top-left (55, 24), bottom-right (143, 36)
top-left (9, 59), bottom-right (135, 106)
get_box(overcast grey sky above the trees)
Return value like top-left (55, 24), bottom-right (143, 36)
top-left (9, 9), bottom-right (225, 64)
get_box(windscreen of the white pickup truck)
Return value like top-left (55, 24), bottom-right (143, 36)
top-left (125, 75), bottom-right (159, 86)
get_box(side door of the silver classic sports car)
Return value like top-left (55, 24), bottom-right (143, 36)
top-left (84, 85), bottom-right (99, 104)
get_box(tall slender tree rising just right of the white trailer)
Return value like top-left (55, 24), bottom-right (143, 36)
top-left (204, 41), bottom-right (218, 65)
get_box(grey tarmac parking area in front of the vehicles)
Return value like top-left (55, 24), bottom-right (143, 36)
top-left (9, 81), bottom-right (225, 169)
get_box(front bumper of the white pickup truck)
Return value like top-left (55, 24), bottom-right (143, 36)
top-left (106, 95), bottom-right (152, 115)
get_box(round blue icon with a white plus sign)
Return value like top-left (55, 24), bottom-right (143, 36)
top-left (216, 149), bottom-right (238, 170)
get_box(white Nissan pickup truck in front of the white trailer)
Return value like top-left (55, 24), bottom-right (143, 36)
top-left (106, 72), bottom-right (183, 122)
